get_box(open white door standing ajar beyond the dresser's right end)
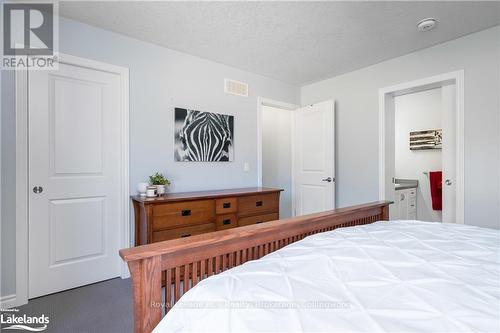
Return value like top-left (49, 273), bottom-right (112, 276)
top-left (293, 101), bottom-right (335, 216)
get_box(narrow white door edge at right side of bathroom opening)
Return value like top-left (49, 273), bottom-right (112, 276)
top-left (441, 84), bottom-right (457, 223)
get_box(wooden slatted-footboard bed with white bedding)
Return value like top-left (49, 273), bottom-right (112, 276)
top-left (121, 203), bottom-right (500, 332)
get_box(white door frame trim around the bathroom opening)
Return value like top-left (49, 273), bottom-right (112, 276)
top-left (378, 70), bottom-right (464, 224)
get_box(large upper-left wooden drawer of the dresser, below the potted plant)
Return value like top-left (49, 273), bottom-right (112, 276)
top-left (153, 200), bottom-right (215, 231)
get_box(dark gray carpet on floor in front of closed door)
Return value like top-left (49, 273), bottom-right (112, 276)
top-left (15, 278), bottom-right (134, 333)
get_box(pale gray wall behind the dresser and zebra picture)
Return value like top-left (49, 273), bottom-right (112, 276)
top-left (1, 19), bottom-right (299, 296)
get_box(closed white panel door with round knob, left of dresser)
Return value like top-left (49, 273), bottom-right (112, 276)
top-left (28, 57), bottom-right (121, 298)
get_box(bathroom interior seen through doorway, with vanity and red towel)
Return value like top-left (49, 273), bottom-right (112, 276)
top-left (393, 88), bottom-right (443, 222)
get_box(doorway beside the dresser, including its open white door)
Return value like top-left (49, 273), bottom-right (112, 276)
top-left (258, 99), bottom-right (335, 218)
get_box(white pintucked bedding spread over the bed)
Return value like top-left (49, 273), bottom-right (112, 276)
top-left (154, 221), bottom-right (500, 332)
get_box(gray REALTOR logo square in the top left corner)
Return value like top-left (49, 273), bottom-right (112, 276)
top-left (1, 0), bottom-right (58, 69)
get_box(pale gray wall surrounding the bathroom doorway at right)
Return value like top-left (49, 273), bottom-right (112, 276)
top-left (301, 27), bottom-right (500, 228)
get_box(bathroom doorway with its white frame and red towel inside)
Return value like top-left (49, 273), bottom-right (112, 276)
top-left (379, 71), bottom-right (464, 223)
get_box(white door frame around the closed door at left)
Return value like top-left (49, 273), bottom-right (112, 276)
top-left (11, 53), bottom-right (131, 307)
